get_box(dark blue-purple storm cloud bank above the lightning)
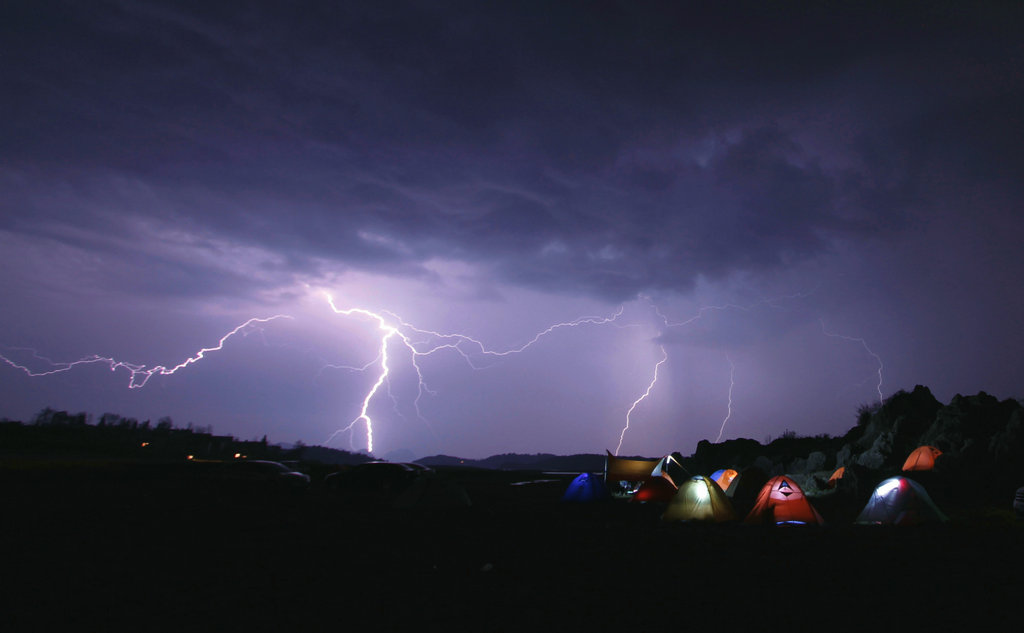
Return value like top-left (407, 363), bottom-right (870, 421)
top-left (0, 2), bottom-right (1021, 299)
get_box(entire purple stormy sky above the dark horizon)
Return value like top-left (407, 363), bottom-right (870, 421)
top-left (0, 0), bottom-right (1024, 457)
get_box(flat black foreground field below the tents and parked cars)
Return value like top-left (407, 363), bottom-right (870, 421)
top-left (0, 464), bottom-right (1024, 631)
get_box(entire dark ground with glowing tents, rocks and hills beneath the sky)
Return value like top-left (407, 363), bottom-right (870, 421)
top-left (0, 387), bottom-right (1024, 631)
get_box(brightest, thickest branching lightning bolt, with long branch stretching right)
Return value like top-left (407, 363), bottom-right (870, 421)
top-left (327, 294), bottom-right (625, 453)
